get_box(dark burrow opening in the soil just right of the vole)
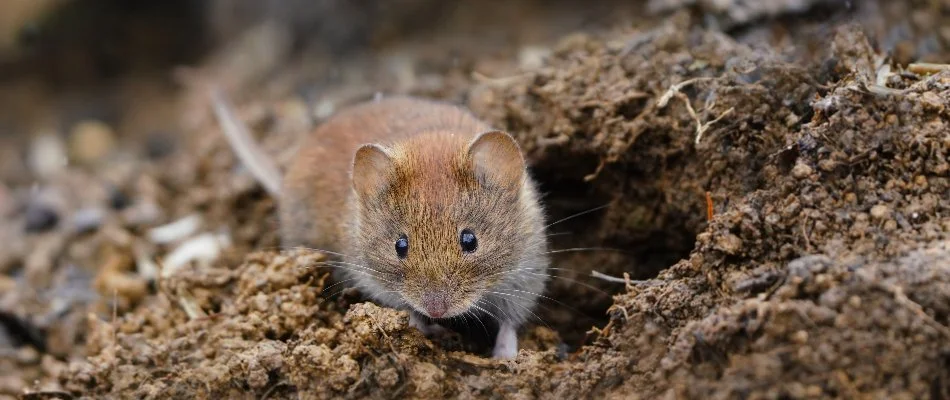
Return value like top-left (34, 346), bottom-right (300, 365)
top-left (529, 146), bottom-right (696, 351)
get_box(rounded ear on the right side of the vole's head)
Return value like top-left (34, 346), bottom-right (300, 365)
top-left (468, 131), bottom-right (525, 189)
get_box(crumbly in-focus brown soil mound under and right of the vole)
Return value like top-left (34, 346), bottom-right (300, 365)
top-left (50, 17), bottom-right (950, 398)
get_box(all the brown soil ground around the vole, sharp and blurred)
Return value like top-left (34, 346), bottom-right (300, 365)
top-left (0, 1), bottom-right (950, 399)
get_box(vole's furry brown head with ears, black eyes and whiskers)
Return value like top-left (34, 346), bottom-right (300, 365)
top-left (352, 131), bottom-right (545, 318)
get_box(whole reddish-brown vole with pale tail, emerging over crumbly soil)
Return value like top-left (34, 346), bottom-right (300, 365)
top-left (208, 94), bottom-right (550, 358)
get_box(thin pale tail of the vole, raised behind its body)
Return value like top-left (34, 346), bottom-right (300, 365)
top-left (211, 89), bottom-right (281, 198)
